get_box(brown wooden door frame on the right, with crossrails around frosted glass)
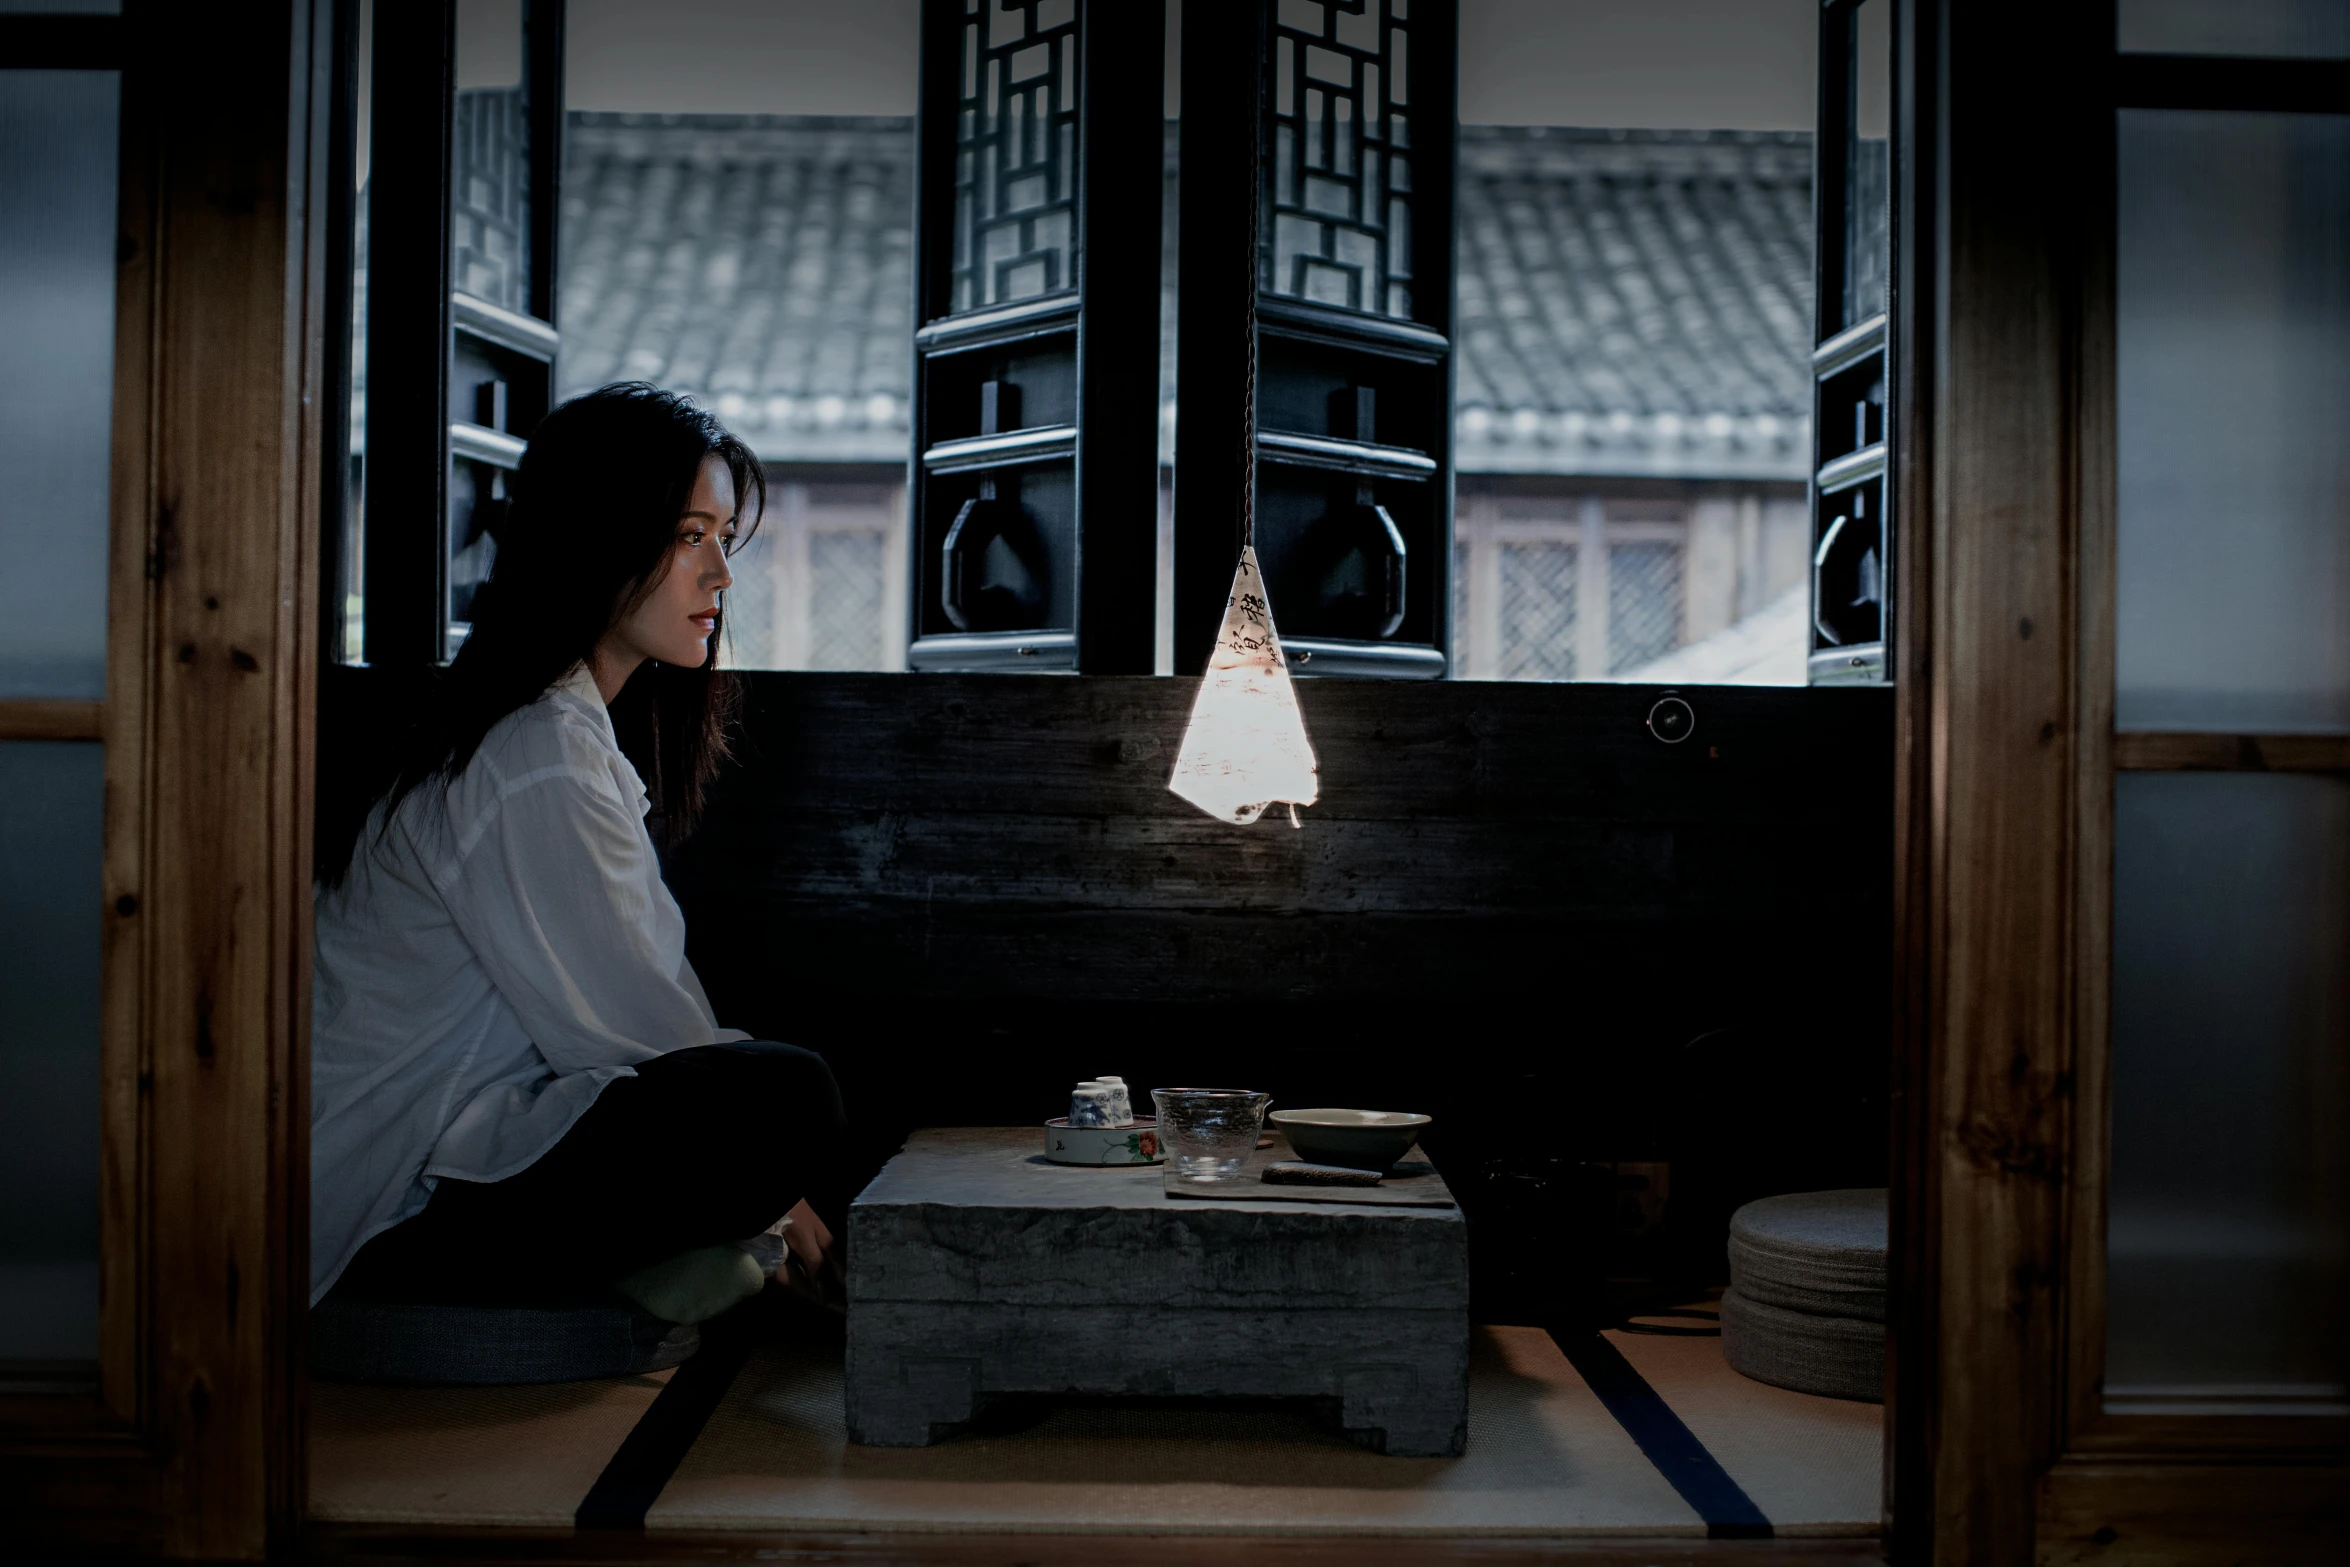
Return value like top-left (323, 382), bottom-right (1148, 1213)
top-left (1887, 0), bottom-right (2350, 1562)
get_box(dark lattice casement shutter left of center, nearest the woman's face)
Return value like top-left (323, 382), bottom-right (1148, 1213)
top-left (907, 0), bottom-right (1166, 674)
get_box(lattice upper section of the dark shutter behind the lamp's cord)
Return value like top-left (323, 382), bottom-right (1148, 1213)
top-left (1260, 0), bottom-right (1412, 320)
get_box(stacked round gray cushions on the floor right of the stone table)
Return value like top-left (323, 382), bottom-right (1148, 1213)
top-left (1723, 1186), bottom-right (1885, 1403)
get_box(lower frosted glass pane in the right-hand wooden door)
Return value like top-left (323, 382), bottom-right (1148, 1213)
top-left (2106, 773), bottom-right (2350, 1407)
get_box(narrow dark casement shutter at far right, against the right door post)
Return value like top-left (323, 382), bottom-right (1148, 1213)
top-left (1810, 0), bottom-right (1894, 684)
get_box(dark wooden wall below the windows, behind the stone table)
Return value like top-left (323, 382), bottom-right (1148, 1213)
top-left (322, 670), bottom-right (1892, 1287)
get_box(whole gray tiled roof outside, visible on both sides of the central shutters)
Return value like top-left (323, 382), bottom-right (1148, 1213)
top-left (562, 115), bottom-right (1812, 479)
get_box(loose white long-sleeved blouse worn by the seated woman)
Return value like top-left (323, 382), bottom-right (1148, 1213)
top-left (310, 665), bottom-right (750, 1302)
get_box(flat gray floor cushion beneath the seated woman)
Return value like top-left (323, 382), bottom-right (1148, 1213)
top-left (310, 1294), bottom-right (700, 1386)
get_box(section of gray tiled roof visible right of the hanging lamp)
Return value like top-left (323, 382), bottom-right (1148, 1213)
top-left (1452, 127), bottom-right (1812, 479)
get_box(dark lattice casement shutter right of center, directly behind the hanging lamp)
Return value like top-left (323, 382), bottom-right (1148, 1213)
top-left (1175, 0), bottom-right (1457, 677)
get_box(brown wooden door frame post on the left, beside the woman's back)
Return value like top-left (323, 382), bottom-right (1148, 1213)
top-left (0, 0), bottom-right (334, 1558)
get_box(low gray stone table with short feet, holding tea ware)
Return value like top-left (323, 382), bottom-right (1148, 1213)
top-left (848, 1128), bottom-right (1469, 1457)
